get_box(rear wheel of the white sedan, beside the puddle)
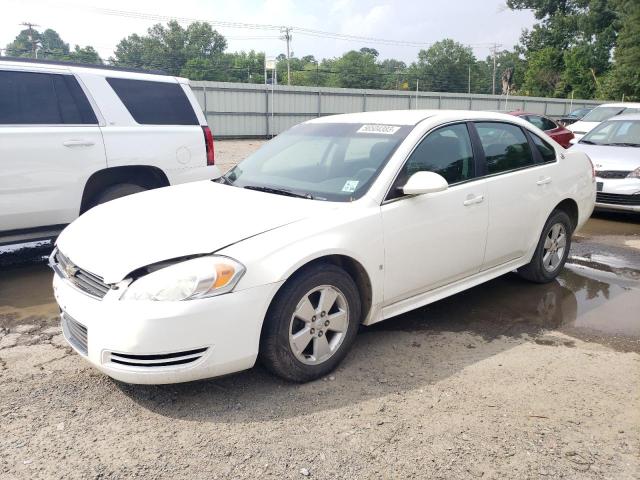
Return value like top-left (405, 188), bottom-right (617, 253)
top-left (518, 210), bottom-right (573, 283)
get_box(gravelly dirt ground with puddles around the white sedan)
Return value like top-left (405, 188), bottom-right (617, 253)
top-left (0, 142), bottom-right (640, 480)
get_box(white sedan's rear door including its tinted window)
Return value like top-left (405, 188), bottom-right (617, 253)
top-left (475, 121), bottom-right (555, 270)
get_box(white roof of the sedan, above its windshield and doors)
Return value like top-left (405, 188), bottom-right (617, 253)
top-left (307, 110), bottom-right (526, 125)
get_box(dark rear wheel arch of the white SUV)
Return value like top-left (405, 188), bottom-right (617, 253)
top-left (80, 165), bottom-right (170, 214)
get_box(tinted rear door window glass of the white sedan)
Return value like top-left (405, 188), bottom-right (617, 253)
top-left (476, 122), bottom-right (534, 175)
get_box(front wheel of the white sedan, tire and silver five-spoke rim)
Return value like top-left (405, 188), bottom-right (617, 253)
top-left (260, 264), bottom-right (361, 382)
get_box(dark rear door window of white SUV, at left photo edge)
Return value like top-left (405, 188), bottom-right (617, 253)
top-left (0, 71), bottom-right (98, 125)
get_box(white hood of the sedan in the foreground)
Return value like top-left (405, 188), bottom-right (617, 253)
top-left (56, 181), bottom-right (336, 283)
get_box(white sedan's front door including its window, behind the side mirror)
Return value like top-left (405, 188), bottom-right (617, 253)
top-left (382, 123), bottom-right (488, 305)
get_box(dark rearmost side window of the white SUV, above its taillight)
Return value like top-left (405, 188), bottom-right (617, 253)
top-left (107, 78), bottom-right (199, 125)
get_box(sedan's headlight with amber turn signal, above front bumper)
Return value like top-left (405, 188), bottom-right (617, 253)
top-left (121, 255), bottom-right (245, 301)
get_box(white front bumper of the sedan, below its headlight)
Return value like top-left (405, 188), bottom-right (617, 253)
top-left (53, 275), bottom-right (280, 384)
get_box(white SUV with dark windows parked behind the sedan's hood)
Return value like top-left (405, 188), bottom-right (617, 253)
top-left (0, 59), bottom-right (219, 244)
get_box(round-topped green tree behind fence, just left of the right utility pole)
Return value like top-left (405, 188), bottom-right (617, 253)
top-left (411, 38), bottom-right (476, 92)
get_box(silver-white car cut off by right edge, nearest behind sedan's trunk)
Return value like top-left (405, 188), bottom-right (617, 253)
top-left (571, 113), bottom-right (640, 212)
